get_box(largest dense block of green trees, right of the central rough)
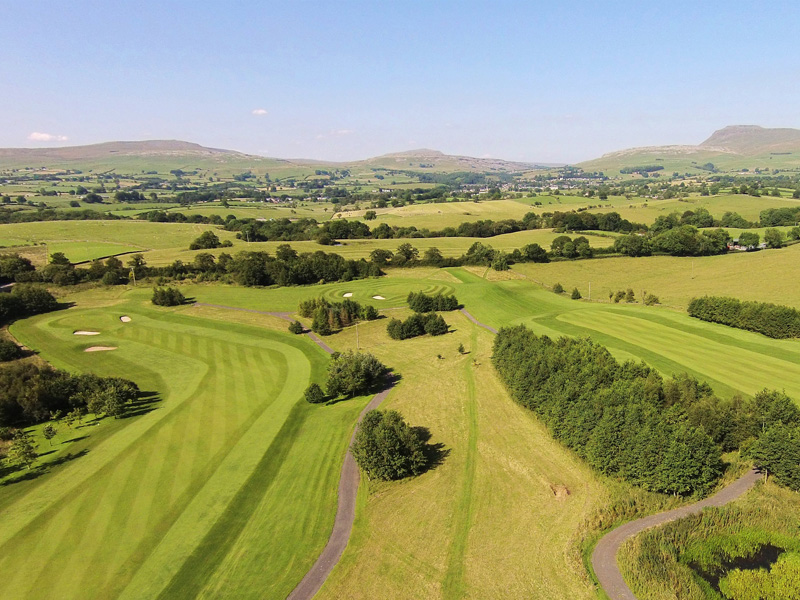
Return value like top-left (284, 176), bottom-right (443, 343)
top-left (492, 326), bottom-right (793, 495)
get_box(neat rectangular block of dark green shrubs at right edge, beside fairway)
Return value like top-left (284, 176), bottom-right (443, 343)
top-left (688, 296), bottom-right (800, 339)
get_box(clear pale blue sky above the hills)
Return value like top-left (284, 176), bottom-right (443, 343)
top-left (0, 0), bottom-right (800, 162)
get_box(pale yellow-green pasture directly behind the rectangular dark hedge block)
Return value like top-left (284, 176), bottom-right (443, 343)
top-left (512, 244), bottom-right (800, 310)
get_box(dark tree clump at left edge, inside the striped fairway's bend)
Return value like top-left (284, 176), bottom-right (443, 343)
top-left (0, 363), bottom-right (139, 427)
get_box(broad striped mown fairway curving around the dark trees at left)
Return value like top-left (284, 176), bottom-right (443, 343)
top-left (0, 296), bottom-right (364, 599)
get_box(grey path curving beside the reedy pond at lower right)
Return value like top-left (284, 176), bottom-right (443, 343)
top-left (592, 470), bottom-right (761, 600)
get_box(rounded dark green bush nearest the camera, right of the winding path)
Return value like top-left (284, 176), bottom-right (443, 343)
top-left (352, 410), bottom-right (427, 481)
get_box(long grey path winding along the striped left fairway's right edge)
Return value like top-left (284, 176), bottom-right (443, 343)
top-left (194, 302), bottom-right (395, 600)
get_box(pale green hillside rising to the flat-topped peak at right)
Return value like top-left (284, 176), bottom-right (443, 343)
top-left (577, 125), bottom-right (800, 175)
